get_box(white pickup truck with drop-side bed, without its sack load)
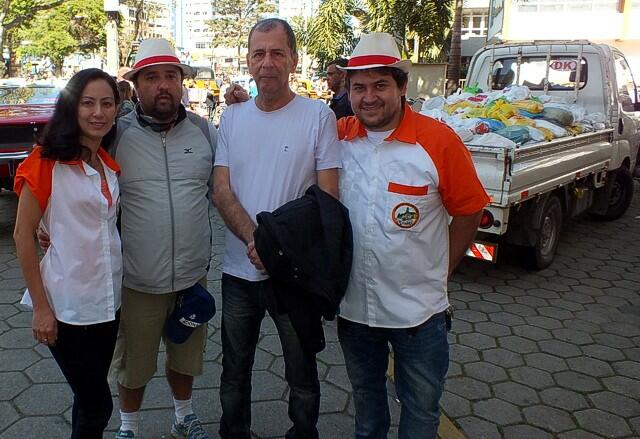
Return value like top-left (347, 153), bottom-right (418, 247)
top-left (467, 41), bottom-right (640, 269)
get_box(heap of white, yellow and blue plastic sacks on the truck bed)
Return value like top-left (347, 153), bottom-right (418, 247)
top-left (420, 85), bottom-right (606, 148)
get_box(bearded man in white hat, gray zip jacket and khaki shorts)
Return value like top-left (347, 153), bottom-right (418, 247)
top-left (111, 39), bottom-right (217, 439)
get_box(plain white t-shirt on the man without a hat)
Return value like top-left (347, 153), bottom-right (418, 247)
top-left (215, 96), bottom-right (341, 281)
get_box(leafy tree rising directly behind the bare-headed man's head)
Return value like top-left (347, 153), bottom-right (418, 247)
top-left (207, 0), bottom-right (276, 69)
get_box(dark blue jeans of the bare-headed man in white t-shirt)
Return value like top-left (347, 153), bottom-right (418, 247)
top-left (220, 274), bottom-right (320, 439)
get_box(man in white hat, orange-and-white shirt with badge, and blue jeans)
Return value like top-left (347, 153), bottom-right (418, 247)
top-left (338, 33), bottom-right (488, 439)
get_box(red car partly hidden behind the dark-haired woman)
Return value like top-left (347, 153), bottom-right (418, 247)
top-left (0, 85), bottom-right (60, 190)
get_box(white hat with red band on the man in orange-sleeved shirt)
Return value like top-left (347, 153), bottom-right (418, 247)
top-left (336, 32), bottom-right (411, 73)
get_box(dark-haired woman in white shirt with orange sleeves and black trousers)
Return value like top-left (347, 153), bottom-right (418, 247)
top-left (13, 69), bottom-right (122, 439)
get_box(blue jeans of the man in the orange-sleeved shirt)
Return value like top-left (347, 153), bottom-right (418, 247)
top-left (338, 313), bottom-right (449, 439)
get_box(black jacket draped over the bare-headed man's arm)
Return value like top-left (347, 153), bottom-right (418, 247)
top-left (254, 185), bottom-right (353, 353)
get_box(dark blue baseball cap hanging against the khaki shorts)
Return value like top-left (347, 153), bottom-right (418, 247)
top-left (165, 283), bottom-right (216, 344)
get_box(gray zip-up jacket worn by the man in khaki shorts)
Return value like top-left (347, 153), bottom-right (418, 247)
top-left (111, 106), bottom-right (217, 293)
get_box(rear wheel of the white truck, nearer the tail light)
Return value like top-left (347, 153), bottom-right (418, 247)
top-left (524, 195), bottom-right (562, 270)
